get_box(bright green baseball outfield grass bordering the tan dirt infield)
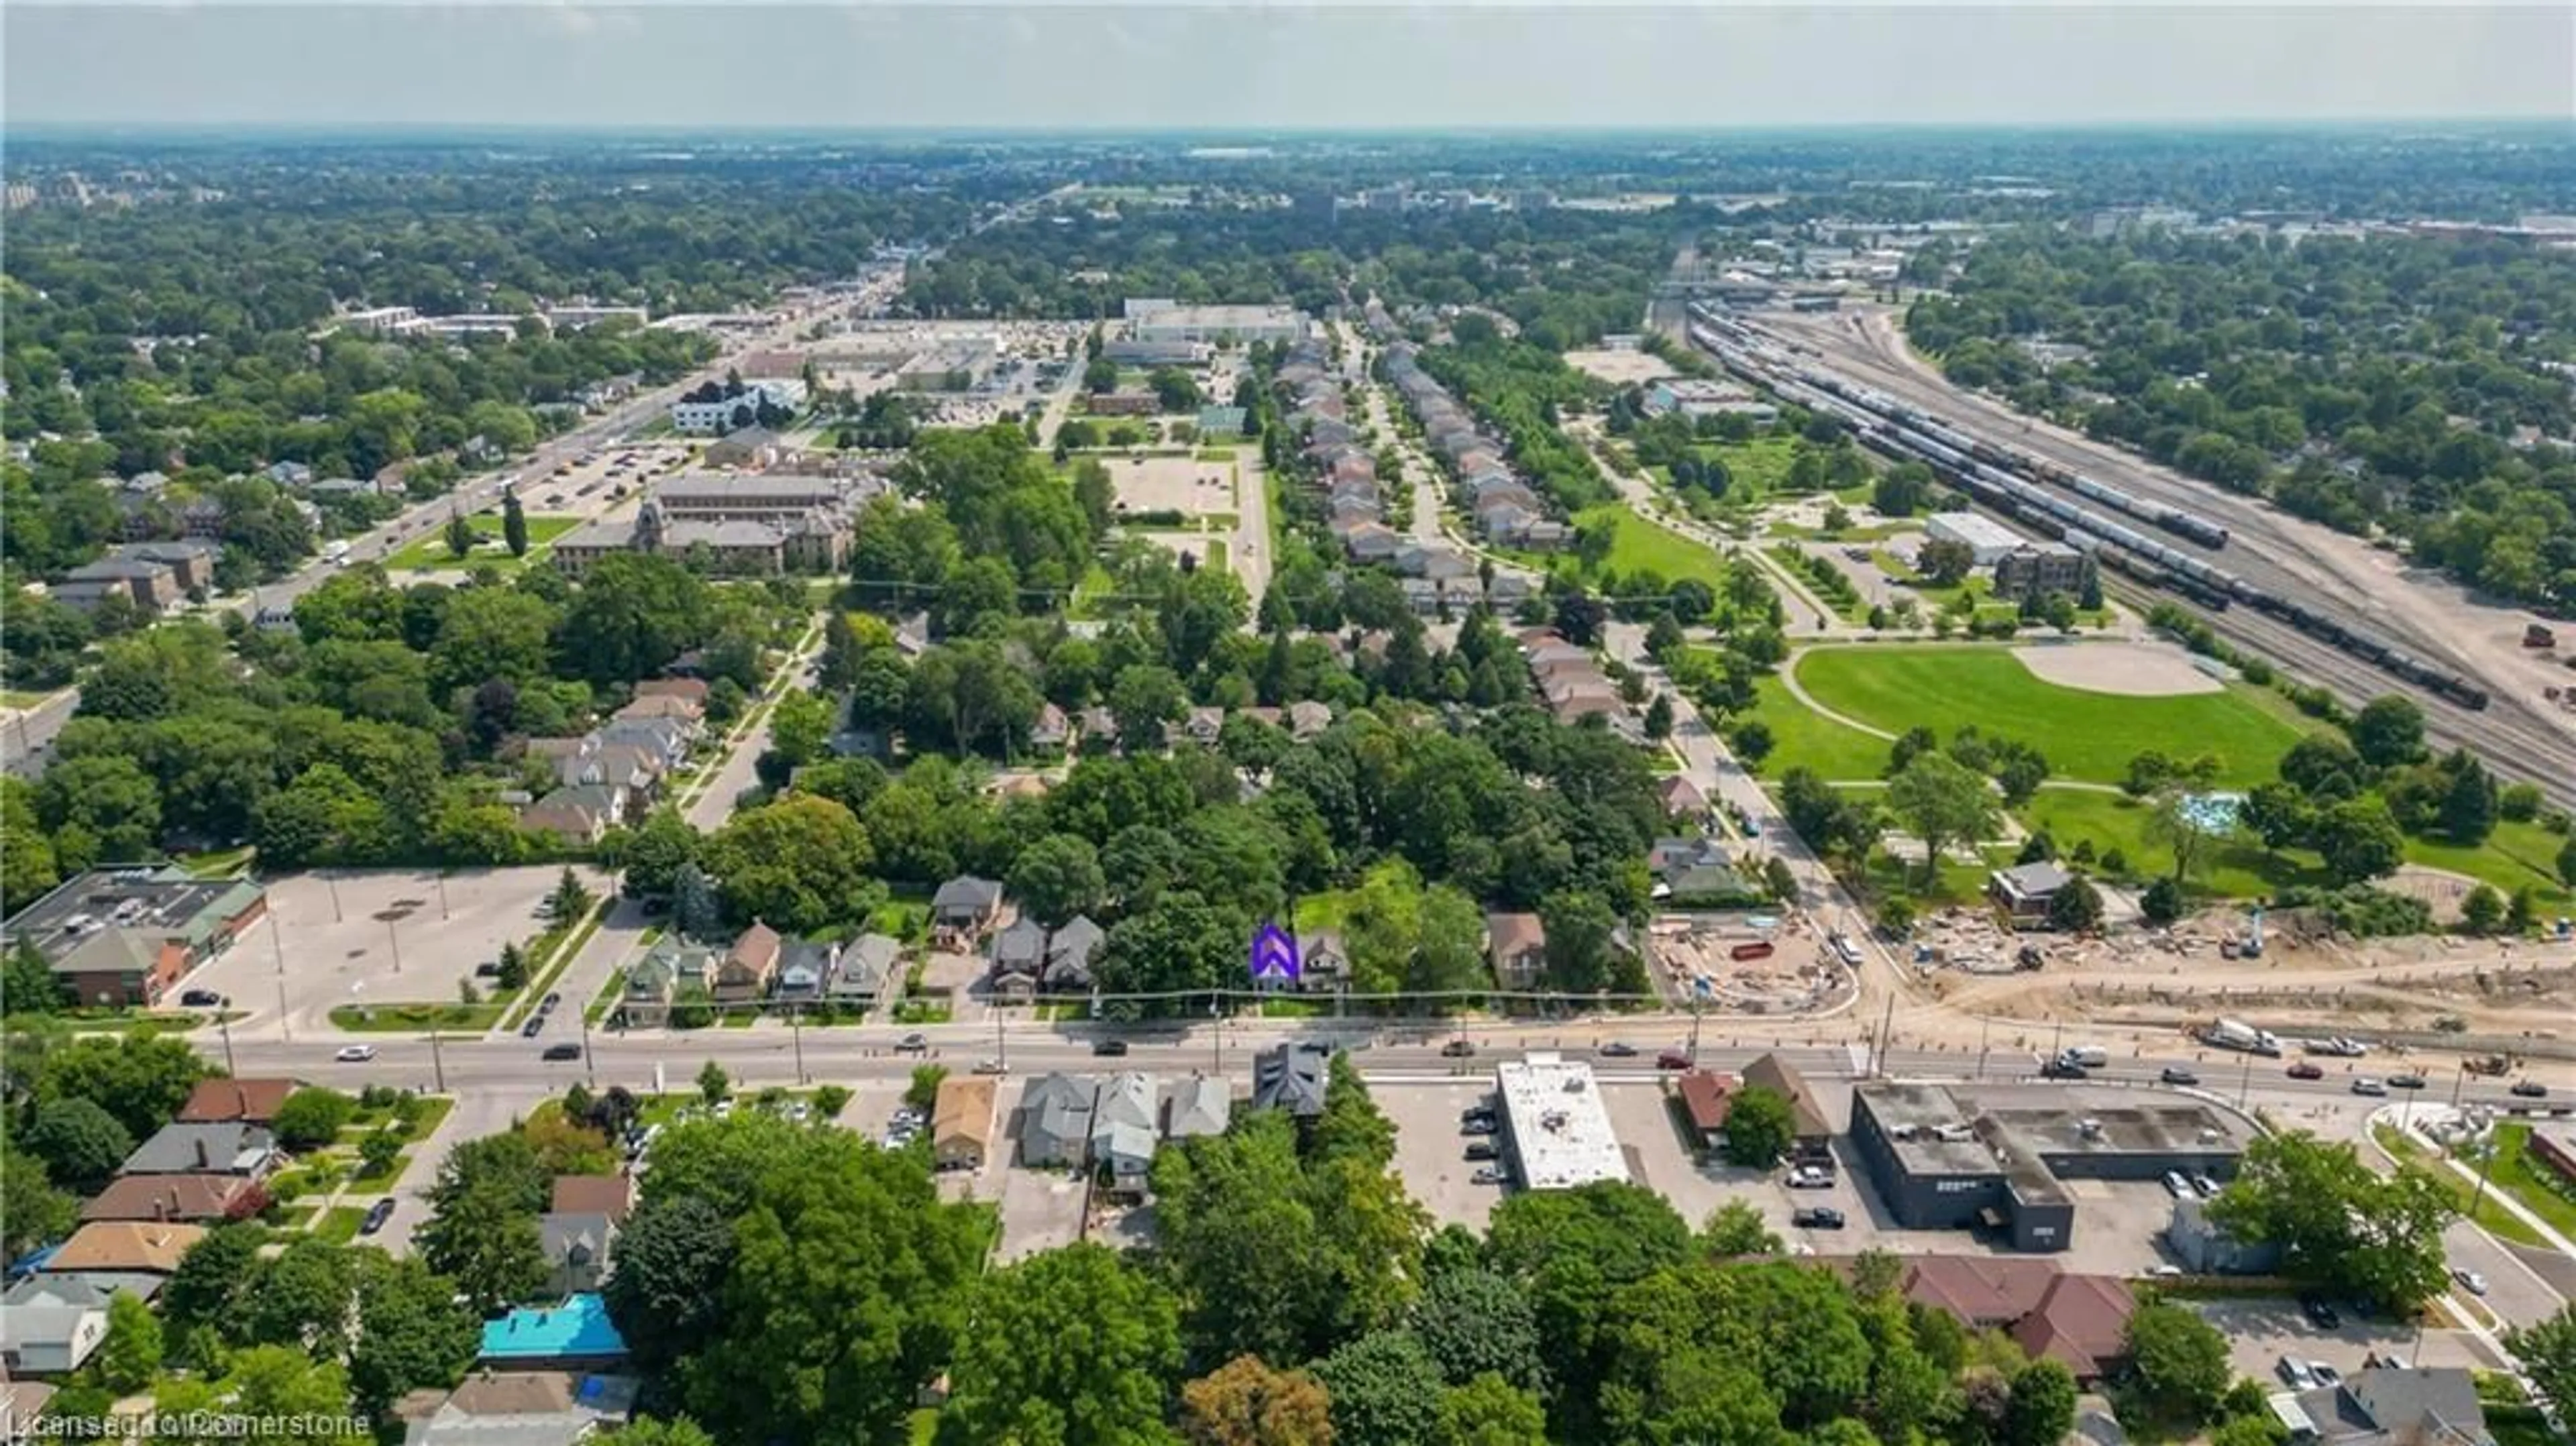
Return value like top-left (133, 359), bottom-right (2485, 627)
top-left (1772, 647), bottom-right (2300, 786)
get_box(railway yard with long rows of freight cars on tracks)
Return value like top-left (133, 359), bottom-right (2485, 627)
top-left (1693, 307), bottom-right (2576, 804)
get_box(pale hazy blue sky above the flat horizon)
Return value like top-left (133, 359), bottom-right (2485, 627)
top-left (15, 0), bottom-right (2576, 129)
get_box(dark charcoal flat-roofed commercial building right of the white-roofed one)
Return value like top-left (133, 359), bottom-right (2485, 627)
top-left (1852, 1082), bottom-right (2246, 1250)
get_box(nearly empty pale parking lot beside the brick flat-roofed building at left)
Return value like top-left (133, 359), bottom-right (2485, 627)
top-left (183, 863), bottom-right (613, 1031)
